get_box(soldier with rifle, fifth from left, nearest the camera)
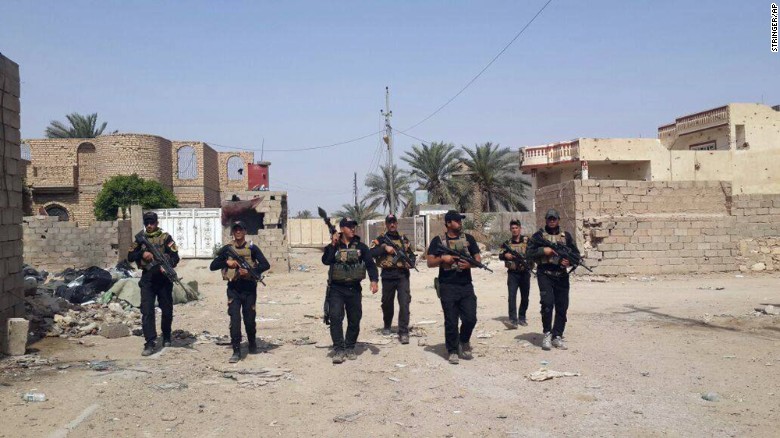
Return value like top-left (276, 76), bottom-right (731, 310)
top-left (427, 210), bottom-right (482, 365)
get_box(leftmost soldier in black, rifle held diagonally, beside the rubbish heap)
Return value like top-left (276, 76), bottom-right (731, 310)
top-left (127, 211), bottom-right (179, 356)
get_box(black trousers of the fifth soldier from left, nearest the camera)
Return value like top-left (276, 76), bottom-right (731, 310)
top-left (439, 283), bottom-right (477, 354)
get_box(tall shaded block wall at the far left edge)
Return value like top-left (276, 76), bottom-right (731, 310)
top-left (0, 54), bottom-right (24, 350)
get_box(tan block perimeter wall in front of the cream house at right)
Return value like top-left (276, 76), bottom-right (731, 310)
top-left (536, 180), bottom-right (780, 275)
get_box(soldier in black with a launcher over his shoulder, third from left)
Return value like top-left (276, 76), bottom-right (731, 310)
top-left (322, 217), bottom-right (379, 364)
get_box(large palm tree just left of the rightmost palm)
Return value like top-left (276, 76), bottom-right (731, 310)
top-left (401, 142), bottom-right (462, 204)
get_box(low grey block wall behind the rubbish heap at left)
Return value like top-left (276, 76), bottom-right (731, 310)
top-left (23, 216), bottom-right (132, 272)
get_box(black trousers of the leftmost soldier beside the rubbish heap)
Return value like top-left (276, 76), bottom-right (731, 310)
top-left (138, 276), bottom-right (173, 344)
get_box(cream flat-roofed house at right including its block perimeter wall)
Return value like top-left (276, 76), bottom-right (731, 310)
top-left (520, 103), bottom-right (780, 275)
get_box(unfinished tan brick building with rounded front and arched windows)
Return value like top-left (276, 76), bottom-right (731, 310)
top-left (22, 134), bottom-right (254, 226)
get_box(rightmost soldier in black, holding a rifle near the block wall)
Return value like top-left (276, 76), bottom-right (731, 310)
top-left (528, 209), bottom-right (580, 350)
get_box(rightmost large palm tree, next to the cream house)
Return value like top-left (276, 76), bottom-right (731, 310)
top-left (463, 142), bottom-right (531, 212)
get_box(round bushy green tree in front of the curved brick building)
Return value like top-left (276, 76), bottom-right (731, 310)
top-left (94, 173), bottom-right (179, 221)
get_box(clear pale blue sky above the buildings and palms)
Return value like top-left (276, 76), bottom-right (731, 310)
top-left (0, 0), bottom-right (780, 214)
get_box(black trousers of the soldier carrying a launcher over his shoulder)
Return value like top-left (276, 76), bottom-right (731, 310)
top-left (328, 283), bottom-right (363, 351)
